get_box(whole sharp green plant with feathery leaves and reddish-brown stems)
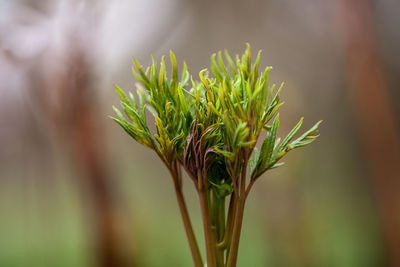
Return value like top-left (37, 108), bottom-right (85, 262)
top-left (113, 45), bottom-right (320, 267)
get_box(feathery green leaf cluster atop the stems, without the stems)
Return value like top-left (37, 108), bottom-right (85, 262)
top-left (113, 45), bottom-right (320, 193)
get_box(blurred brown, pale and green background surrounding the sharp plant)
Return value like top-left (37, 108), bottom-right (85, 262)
top-left (0, 0), bottom-right (400, 267)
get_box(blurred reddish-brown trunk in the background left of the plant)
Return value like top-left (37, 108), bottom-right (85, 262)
top-left (64, 52), bottom-right (133, 267)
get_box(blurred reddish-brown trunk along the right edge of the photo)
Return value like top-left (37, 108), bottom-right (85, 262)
top-left (337, 0), bottom-right (400, 266)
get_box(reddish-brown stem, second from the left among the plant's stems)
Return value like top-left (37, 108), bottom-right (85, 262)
top-left (199, 185), bottom-right (216, 267)
